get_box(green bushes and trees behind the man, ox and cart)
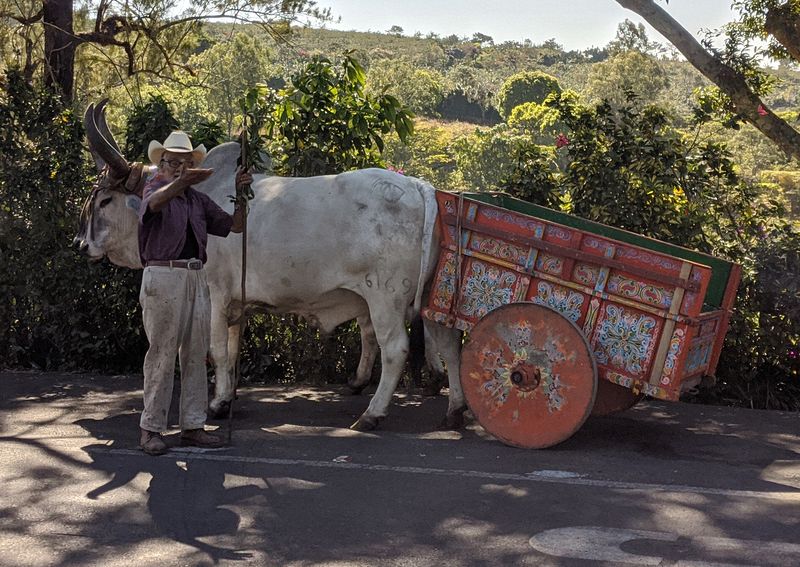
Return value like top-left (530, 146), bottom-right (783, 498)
top-left (0, 0), bottom-right (800, 410)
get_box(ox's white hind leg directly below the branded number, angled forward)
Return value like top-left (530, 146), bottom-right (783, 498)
top-left (350, 305), bottom-right (408, 431)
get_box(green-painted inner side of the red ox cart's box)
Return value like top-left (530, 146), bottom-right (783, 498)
top-left (464, 193), bottom-right (733, 311)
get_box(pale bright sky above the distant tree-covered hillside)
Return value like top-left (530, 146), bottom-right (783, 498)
top-left (317, 0), bottom-right (734, 50)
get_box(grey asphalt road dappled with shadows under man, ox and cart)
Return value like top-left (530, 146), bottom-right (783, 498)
top-left (0, 373), bottom-right (800, 567)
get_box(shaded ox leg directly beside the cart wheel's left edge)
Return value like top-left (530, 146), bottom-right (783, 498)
top-left (423, 319), bottom-right (467, 429)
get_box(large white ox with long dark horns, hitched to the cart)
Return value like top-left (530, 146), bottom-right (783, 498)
top-left (75, 103), bottom-right (466, 430)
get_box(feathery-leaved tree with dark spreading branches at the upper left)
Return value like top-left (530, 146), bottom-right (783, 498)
top-left (0, 0), bottom-right (329, 101)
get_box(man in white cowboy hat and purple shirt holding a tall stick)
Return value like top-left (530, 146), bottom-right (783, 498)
top-left (139, 131), bottom-right (252, 455)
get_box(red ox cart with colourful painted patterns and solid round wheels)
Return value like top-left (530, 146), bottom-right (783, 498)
top-left (422, 191), bottom-right (741, 448)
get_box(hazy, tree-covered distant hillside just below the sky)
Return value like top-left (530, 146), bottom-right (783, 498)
top-left (200, 25), bottom-right (800, 124)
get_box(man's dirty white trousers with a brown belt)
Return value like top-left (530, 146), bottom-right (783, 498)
top-left (139, 266), bottom-right (211, 433)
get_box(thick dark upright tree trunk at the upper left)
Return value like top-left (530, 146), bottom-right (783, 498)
top-left (42, 0), bottom-right (77, 103)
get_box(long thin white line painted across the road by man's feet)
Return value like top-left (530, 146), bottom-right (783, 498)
top-left (90, 448), bottom-right (800, 502)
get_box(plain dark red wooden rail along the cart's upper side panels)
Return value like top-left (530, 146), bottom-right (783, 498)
top-left (441, 213), bottom-right (701, 292)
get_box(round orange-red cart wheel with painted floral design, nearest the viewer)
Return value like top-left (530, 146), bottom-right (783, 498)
top-left (461, 303), bottom-right (597, 449)
